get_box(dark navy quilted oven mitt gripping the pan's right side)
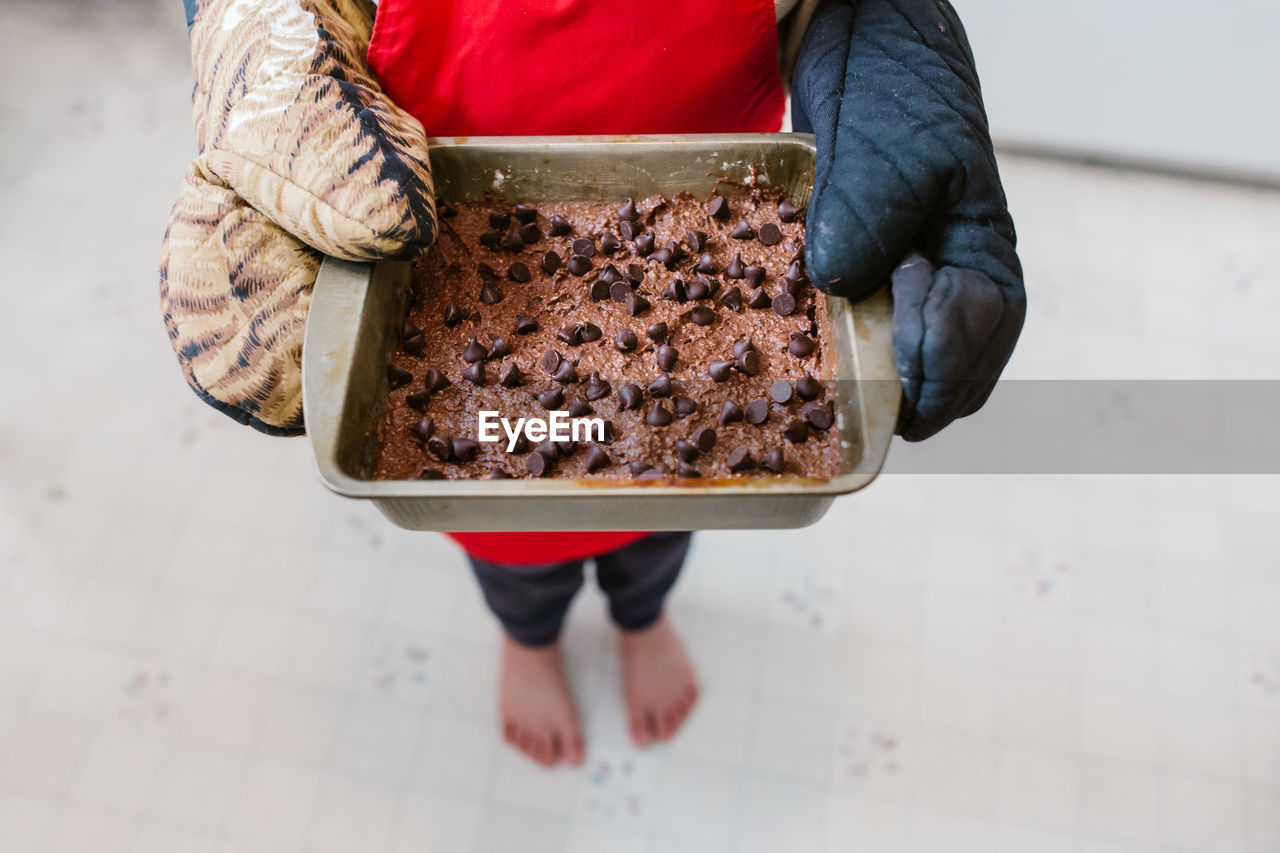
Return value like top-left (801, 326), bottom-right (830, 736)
top-left (792, 0), bottom-right (1027, 441)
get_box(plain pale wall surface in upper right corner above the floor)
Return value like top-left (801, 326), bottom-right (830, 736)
top-left (952, 0), bottom-right (1280, 179)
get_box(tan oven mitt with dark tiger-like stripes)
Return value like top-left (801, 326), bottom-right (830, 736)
top-left (160, 0), bottom-right (435, 435)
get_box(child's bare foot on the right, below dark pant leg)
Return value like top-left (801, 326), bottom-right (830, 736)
top-left (622, 616), bottom-right (698, 747)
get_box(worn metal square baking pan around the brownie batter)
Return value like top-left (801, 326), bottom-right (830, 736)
top-left (302, 133), bottom-right (901, 530)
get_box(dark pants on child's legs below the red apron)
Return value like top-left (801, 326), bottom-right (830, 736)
top-left (470, 533), bottom-right (692, 646)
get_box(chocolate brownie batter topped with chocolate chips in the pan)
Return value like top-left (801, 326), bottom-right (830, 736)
top-left (375, 188), bottom-right (841, 479)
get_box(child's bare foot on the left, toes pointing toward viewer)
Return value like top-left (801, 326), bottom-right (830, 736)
top-left (498, 637), bottom-right (582, 767)
